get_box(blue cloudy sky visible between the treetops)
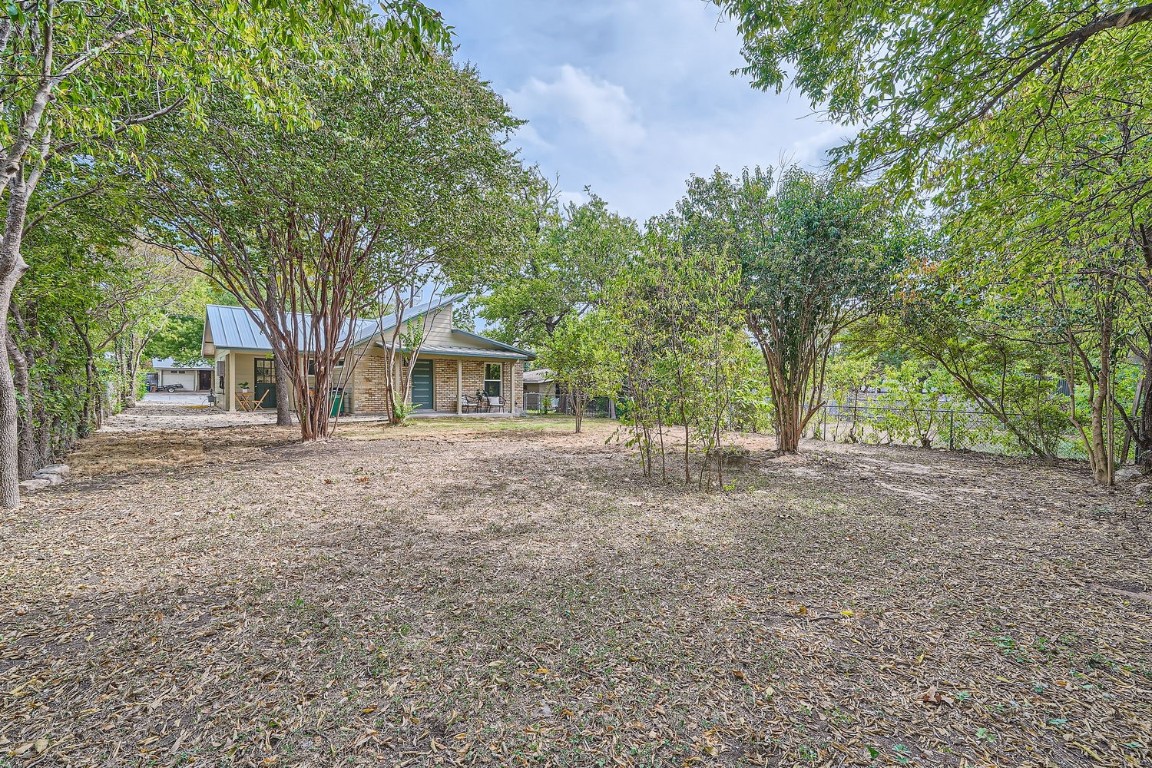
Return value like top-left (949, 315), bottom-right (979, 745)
top-left (432, 0), bottom-right (849, 222)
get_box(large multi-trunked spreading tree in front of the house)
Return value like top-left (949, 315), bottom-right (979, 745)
top-left (149, 30), bottom-right (522, 440)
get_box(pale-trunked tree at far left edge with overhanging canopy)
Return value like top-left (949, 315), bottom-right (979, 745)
top-left (0, 0), bottom-right (448, 508)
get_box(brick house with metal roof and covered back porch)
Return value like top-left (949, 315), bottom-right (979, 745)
top-left (202, 296), bottom-right (535, 413)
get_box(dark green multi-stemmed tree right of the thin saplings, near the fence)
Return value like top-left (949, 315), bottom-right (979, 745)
top-left (675, 167), bottom-right (908, 453)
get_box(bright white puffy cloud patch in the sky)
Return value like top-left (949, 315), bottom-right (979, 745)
top-left (508, 64), bottom-right (647, 152)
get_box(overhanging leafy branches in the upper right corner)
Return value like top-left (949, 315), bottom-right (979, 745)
top-left (714, 0), bottom-right (1152, 182)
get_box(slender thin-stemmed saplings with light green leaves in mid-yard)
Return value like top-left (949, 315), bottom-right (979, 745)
top-left (606, 231), bottom-right (765, 487)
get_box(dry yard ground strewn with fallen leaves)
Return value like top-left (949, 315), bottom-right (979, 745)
top-left (0, 406), bottom-right (1152, 768)
